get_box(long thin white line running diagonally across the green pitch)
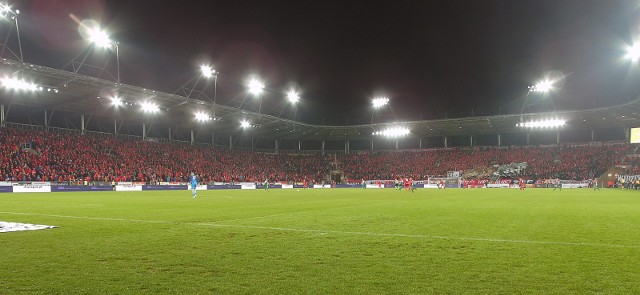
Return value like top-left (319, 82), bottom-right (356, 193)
top-left (0, 211), bottom-right (640, 249)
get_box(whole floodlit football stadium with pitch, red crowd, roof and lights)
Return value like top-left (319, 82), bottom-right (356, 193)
top-left (0, 1), bottom-right (640, 294)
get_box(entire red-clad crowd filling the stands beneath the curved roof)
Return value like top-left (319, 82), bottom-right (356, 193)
top-left (0, 128), bottom-right (630, 182)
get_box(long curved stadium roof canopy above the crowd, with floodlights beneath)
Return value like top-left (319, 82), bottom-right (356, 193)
top-left (0, 59), bottom-right (640, 140)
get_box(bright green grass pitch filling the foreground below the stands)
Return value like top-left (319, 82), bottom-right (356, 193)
top-left (0, 189), bottom-right (640, 294)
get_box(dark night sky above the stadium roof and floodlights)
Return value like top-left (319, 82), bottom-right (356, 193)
top-left (13, 0), bottom-right (640, 124)
